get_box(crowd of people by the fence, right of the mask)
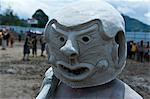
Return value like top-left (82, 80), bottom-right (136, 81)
top-left (127, 40), bottom-right (150, 62)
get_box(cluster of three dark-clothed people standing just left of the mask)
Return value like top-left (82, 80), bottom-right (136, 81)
top-left (23, 32), bottom-right (46, 61)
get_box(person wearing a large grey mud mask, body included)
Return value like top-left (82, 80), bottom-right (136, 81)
top-left (36, 0), bottom-right (142, 99)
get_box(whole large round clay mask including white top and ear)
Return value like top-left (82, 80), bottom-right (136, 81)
top-left (45, 0), bottom-right (126, 88)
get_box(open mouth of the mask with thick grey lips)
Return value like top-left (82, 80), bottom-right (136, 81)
top-left (56, 61), bottom-right (94, 81)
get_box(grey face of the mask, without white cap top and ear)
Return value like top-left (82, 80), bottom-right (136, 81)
top-left (45, 20), bottom-right (126, 88)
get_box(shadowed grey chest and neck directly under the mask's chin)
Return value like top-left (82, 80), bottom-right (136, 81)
top-left (55, 79), bottom-right (125, 99)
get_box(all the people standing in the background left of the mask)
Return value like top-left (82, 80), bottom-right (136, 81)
top-left (0, 28), bottom-right (46, 61)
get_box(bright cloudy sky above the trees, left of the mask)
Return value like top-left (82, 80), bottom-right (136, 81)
top-left (0, 0), bottom-right (74, 18)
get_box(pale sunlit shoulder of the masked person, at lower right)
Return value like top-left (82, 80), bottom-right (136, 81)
top-left (124, 83), bottom-right (143, 99)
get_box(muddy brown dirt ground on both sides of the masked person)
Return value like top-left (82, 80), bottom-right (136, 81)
top-left (0, 42), bottom-right (150, 99)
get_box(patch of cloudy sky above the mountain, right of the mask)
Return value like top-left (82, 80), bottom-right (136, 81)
top-left (105, 0), bottom-right (150, 25)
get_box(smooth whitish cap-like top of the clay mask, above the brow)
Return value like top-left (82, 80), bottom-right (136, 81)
top-left (51, 0), bottom-right (124, 37)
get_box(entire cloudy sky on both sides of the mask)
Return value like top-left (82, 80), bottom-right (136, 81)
top-left (0, 0), bottom-right (150, 25)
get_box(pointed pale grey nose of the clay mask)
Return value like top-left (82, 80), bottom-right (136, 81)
top-left (60, 40), bottom-right (79, 58)
